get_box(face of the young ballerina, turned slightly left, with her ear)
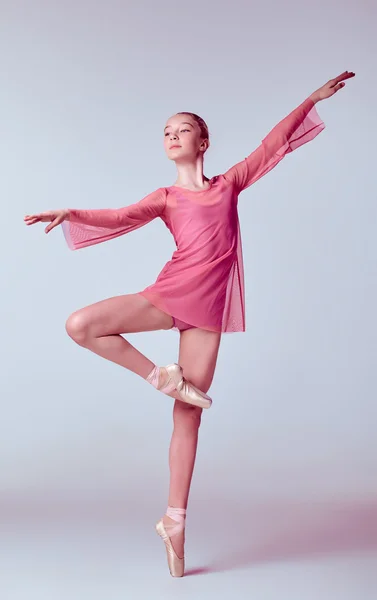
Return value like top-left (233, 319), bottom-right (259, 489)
top-left (164, 115), bottom-right (208, 162)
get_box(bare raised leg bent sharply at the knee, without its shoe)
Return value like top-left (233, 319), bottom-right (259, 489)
top-left (66, 294), bottom-right (173, 379)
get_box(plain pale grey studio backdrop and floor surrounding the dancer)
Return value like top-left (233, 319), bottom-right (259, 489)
top-left (0, 0), bottom-right (377, 600)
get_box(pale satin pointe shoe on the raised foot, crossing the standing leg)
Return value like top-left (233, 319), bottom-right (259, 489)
top-left (147, 363), bottom-right (212, 408)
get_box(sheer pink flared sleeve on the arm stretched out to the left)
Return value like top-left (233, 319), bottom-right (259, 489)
top-left (62, 188), bottom-right (166, 250)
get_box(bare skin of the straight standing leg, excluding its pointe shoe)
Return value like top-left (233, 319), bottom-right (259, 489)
top-left (164, 328), bottom-right (221, 557)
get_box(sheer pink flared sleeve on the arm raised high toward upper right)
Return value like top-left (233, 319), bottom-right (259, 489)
top-left (223, 97), bottom-right (325, 193)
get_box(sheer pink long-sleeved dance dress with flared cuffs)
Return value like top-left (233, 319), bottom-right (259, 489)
top-left (62, 98), bottom-right (325, 333)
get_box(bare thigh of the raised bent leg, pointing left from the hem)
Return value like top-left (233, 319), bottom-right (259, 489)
top-left (66, 294), bottom-right (173, 337)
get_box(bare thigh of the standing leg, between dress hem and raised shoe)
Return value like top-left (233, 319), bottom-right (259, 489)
top-left (178, 327), bottom-right (221, 393)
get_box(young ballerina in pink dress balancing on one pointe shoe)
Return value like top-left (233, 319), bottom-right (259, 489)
top-left (25, 71), bottom-right (355, 577)
